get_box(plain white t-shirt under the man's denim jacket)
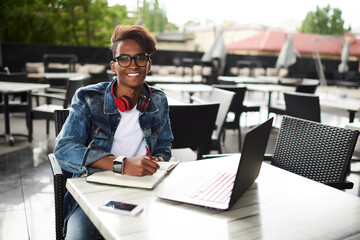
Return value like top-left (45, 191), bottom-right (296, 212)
top-left (111, 106), bottom-right (146, 157)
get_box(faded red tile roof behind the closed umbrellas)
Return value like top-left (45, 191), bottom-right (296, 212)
top-left (226, 30), bottom-right (360, 57)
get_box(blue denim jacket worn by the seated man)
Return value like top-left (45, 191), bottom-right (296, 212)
top-left (54, 79), bottom-right (173, 233)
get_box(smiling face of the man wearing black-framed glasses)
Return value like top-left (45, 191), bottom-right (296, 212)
top-left (110, 39), bottom-right (151, 88)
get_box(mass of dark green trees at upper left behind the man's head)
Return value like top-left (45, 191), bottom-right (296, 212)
top-left (0, 0), bottom-right (176, 46)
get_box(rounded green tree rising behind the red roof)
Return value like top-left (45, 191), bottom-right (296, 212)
top-left (298, 5), bottom-right (351, 35)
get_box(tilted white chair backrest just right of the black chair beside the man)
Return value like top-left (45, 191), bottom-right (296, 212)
top-left (209, 87), bottom-right (235, 139)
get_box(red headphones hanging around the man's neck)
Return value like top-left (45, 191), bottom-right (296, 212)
top-left (111, 80), bottom-right (151, 112)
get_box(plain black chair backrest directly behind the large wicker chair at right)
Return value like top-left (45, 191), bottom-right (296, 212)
top-left (284, 92), bottom-right (321, 122)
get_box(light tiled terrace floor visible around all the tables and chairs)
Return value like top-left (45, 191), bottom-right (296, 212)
top-left (0, 87), bottom-right (360, 240)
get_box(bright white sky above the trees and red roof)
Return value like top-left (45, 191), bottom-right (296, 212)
top-left (108, 0), bottom-right (360, 30)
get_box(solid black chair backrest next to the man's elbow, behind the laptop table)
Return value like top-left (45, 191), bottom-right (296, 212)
top-left (169, 103), bottom-right (219, 157)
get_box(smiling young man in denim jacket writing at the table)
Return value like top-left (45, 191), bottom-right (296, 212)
top-left (54, 25), bottom-right (173, 239)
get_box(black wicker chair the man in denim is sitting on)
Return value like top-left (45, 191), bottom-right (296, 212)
top-left (48, 109), bottom-right (72, 239)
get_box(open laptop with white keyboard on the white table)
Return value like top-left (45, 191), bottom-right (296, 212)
top-left (154, 118), bottom-right (273, 210)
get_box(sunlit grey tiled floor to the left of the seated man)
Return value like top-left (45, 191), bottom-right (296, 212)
top-left (0, 115), bottom-right (55, 239)
